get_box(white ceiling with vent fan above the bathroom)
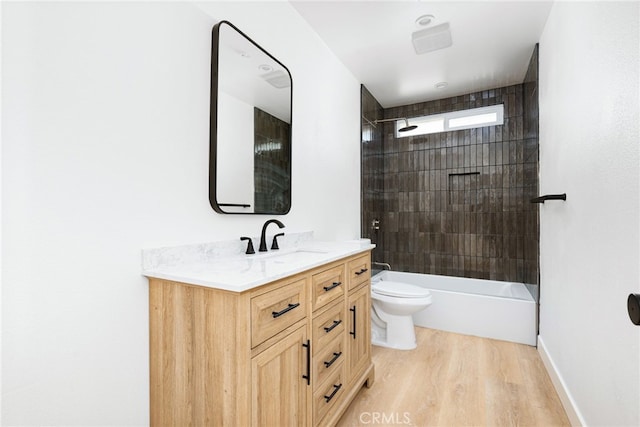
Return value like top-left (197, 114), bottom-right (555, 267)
top-left (290, 0), bottom-right (552, 108)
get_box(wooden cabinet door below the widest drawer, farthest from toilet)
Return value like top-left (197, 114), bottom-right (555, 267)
top-left (251, 326), bottom-right (310, 426)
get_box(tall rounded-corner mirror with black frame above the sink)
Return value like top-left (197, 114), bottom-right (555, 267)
top-left (209, 21), bottom-right (292, 215)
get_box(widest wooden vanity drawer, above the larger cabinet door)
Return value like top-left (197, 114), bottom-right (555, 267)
top-left (251, 278), bottom-right (307, 347)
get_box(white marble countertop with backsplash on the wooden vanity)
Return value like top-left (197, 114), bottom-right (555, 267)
top-left (142, 235), bottom-right (375, 292)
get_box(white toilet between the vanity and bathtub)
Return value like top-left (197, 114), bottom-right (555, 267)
top-left (371, 280), bottom-right (431, 350)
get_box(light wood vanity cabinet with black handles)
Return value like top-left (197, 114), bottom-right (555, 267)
top-left (149, 251), bottom-right (373, 427)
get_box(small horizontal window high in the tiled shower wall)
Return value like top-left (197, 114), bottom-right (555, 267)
top-left (396, 104), bottom-right (504, 138)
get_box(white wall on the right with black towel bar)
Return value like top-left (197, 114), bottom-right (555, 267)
top-left (540, 2), bottom-right (640, 426)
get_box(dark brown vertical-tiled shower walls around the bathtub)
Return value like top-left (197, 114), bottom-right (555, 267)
top-left (362, 48), bottom-right (539, 284)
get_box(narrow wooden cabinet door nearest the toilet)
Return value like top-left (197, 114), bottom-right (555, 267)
top-left (347, 282), bottom-right (371, 380)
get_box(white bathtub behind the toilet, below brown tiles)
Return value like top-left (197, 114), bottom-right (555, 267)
top-left (371, 271), bottom-right (537, 346)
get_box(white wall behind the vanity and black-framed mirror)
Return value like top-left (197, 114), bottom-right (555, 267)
top-left (2, 2), bottom-right (360, 426)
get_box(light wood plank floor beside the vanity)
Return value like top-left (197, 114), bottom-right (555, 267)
top-left (338, 327), bottom-right (570, 427)
